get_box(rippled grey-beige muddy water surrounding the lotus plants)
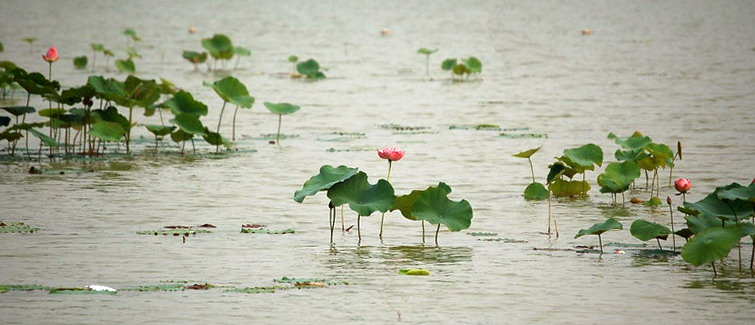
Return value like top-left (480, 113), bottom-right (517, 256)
top-left (0, 0), bottom-right (755, 324)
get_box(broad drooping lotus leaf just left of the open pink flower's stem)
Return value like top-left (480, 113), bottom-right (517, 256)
top-left (328, 172), bottom-right (396, 216)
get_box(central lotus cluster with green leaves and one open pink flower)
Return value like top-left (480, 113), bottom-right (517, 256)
top-left (294, 147), bottom-right (473, 245)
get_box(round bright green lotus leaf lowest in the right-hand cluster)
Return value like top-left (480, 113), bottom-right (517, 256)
top-left (682, 227), bottom-right (741, 265)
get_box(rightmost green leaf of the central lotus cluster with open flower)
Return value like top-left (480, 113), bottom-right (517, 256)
top-left (412, 185), bottom-right (473, 231)
